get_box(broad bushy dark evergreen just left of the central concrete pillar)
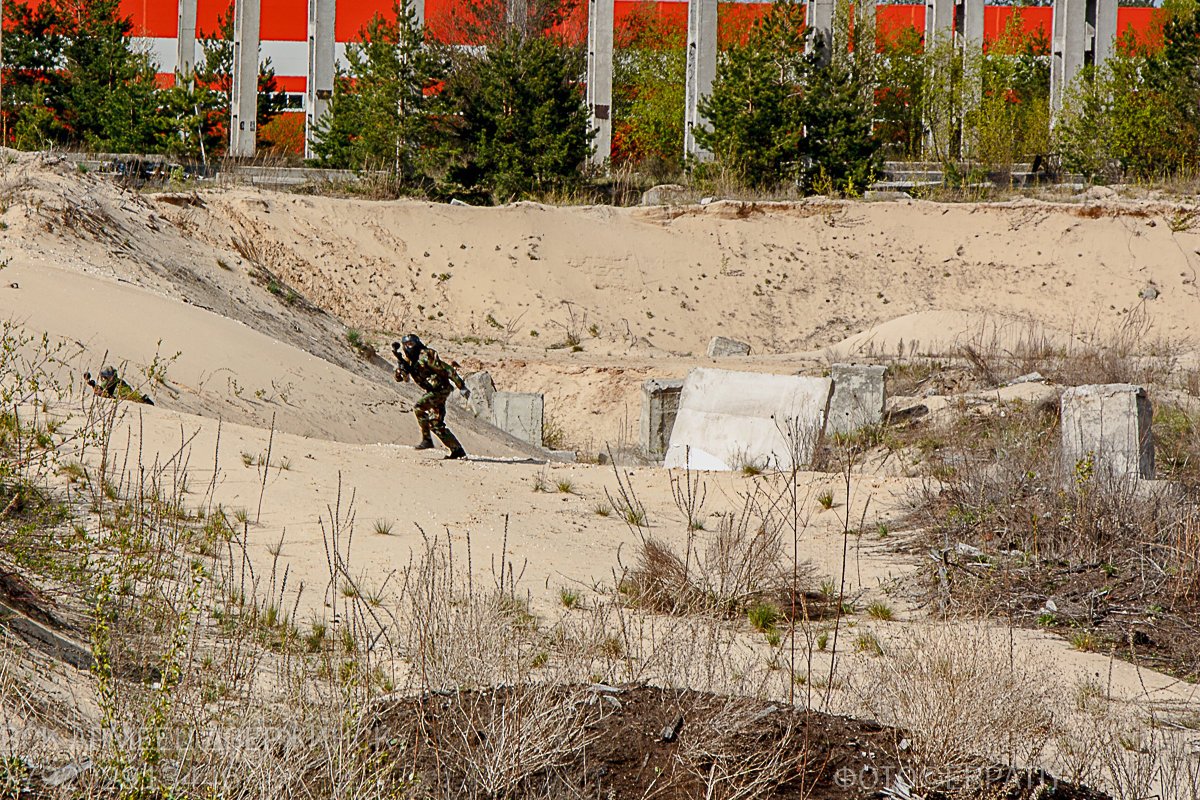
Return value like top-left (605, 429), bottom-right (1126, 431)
top-left (442, 31), bottom-right (592, 203)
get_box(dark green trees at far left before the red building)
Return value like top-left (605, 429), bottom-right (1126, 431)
top-left (4, 0), bottom-right (284, 158)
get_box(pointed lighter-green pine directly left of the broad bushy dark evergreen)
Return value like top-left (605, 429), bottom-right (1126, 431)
top-left (316, 2), bottom-right (445, 184)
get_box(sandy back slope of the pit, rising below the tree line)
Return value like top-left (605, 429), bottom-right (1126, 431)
top-left (0, 154), bottom-right (1200, 451)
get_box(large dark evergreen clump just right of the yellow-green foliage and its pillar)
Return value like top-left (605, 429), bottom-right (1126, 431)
top-left (697, 4), bottom-right (878, 192)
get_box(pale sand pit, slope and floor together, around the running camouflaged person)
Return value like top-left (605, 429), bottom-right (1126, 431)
top-left (0, 155), bottom-right (1200, 788)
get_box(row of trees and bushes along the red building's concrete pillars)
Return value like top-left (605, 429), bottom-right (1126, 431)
top-left (4, 0), bottom-right (1200, 203)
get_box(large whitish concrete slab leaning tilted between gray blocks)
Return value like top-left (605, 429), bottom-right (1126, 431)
top-left (664, 369), bottom-right (833, 470)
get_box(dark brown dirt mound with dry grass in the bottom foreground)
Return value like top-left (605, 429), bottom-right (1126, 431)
top-left (370, 685), bottom-right (1106, 800)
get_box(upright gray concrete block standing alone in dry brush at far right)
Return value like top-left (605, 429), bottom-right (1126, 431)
top-left (1062, 384), bottom-right (1154, 479)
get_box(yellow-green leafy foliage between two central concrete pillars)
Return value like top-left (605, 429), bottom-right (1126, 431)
top-left (612, 4), bottom-right (688, 176)
